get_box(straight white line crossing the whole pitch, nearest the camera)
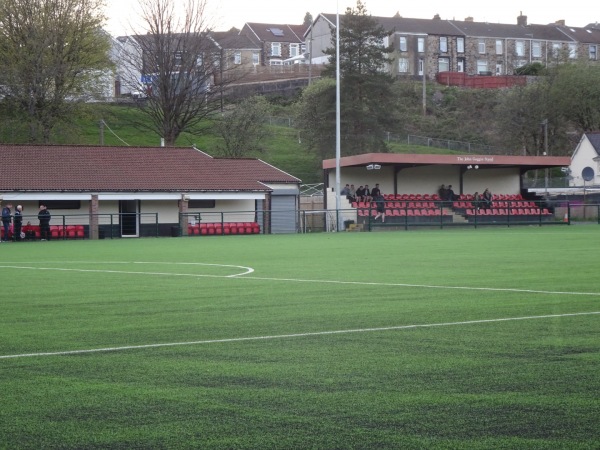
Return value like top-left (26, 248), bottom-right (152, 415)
top-left (0, 311), bottom-right (600, 359)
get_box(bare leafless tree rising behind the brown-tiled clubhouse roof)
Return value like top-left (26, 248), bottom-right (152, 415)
top-left (124, 0), bottom-right (239, 146)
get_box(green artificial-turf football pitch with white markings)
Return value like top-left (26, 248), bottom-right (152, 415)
top-left (0, 225), bottom-right (600, 450)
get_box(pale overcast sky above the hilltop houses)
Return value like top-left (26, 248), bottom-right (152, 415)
top-left (106, 0), bottom-right (600, 35)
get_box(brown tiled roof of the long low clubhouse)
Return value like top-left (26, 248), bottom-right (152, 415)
top-left (0, 145), bottom-right (300, 192)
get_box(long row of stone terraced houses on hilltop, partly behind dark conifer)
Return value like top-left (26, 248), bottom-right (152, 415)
top-left (304, 14), bottom-right (600, 80)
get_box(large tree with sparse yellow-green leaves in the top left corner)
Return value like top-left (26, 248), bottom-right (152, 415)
top-left (0, 0), bottom-right (112, 143)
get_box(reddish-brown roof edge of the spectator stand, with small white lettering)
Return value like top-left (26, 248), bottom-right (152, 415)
top-left (323, 153), bottom-right (571, 170)
